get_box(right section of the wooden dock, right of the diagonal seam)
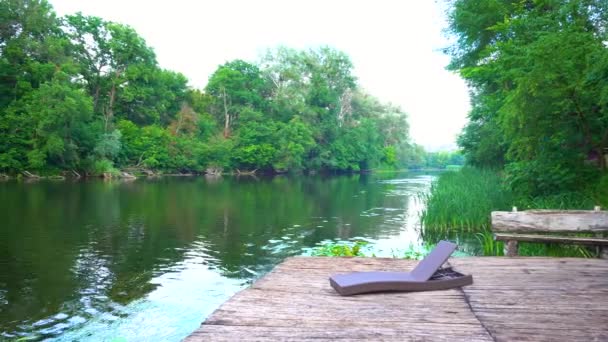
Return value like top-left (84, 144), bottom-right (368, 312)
top-left (450, 257), bottom-right (608, 341)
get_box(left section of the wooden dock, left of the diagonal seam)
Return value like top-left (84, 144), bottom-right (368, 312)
top-left (186, 257), bottom-right (492, 341)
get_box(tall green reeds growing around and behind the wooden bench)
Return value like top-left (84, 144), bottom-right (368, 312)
top-left (421, 167), bottom-right (608, 257)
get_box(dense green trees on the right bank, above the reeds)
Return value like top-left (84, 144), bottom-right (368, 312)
top-left (447, 0), bottom-right (608, 197)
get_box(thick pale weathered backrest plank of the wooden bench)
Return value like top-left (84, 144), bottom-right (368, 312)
top-left (492, 210), bottom-right (608, 233)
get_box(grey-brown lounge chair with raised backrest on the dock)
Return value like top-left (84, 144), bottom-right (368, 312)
top-left (329, 241), bottom-right (473, 296)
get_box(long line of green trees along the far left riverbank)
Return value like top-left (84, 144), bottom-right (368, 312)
top-left (0, 0), bottom-right (446, 174)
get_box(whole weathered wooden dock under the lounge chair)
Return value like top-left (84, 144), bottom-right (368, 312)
top-left (185, 257), bottom-right (608, 342)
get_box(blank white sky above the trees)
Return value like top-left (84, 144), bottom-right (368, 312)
top-left (50, 0), bottom-right (469, 150)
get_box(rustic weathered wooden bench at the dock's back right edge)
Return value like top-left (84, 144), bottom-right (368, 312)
top-left (492, 207), bottom-right (608, 259)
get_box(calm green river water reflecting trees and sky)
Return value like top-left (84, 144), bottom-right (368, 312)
top-left (0, 173), bottom-right (434, 341)
